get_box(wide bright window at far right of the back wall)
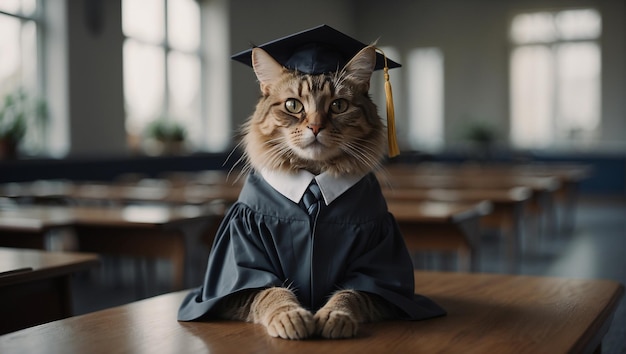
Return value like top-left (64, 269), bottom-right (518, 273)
top-left (510, 9), bottom-right (601, 148)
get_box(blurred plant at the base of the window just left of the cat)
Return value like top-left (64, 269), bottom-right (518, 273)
top-left (145, 117), bottom-right (187, 155)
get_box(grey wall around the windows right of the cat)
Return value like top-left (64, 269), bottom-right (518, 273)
top-left (355, 0), bottom-right (626, 148)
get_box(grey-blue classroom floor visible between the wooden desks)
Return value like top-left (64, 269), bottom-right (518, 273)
top-left (74, 196), bottom-right (626, 354)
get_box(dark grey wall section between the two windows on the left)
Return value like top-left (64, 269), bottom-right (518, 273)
top-left (66, 0), bottom-right (127, 156)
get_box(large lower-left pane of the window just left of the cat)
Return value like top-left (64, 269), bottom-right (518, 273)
top-left (124, 39), bottom-right (165, 134)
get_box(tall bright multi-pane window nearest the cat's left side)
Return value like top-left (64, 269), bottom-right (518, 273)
top-left (122, 0), bottom-right (205, 153)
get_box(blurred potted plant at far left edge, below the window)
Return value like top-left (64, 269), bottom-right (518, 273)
top-left (0, 89), bottom-right (48, 159)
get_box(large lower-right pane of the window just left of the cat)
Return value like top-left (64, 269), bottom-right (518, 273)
top-left (168, 52), bottom-right (202, 142)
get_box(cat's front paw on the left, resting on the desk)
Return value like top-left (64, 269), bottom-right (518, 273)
top-left (267, 308), bottom-right (315, 339)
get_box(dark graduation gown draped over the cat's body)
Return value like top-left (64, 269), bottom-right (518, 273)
top-left (178, 173), bottom-right (445, 321)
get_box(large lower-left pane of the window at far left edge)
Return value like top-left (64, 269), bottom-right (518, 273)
top-left (0, 15), bottom-right (21, 92)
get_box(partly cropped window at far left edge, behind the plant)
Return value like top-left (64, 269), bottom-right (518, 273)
top-left (0, 0), bottom-right (45, 154)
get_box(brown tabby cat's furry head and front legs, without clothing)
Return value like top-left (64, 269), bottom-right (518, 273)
top-left (214, 46), bottom-right (392, 339)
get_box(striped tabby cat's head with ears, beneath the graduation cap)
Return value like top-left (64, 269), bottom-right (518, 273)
top-left (244, 47), bottom-right (385, 175)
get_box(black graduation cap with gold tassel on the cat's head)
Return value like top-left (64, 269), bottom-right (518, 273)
top-left (231, 25), bottom-right (401, 157)
